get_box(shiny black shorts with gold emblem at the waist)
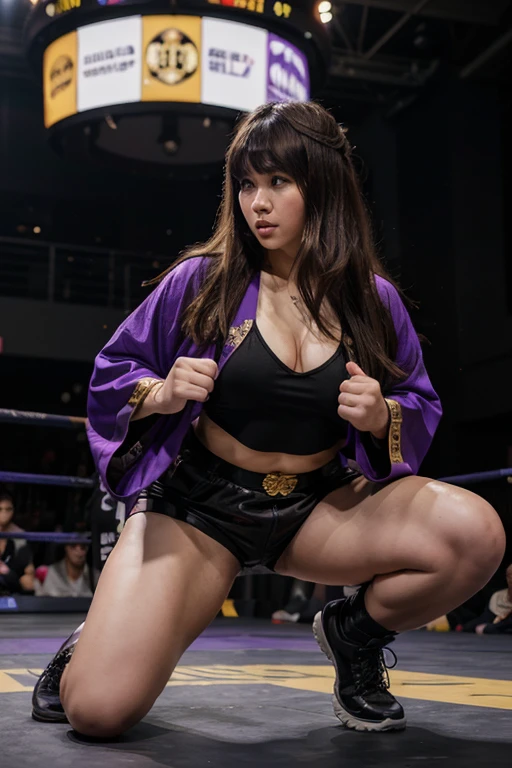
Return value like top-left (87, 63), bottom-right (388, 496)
top-left (129, 427), bottom-right (360, 570)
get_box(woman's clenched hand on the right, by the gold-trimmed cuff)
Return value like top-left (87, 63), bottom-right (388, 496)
top-left (338, 361), bottom-right (389, 439)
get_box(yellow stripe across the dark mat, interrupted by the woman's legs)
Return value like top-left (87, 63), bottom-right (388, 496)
top-left (0, 664), bottom-right (512, 710)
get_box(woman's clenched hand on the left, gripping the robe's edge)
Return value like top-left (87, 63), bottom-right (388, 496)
top-left (151, 357), bottom-right (218, 414)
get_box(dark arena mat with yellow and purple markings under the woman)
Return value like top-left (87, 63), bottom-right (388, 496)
top-left (0, 614), bottom-right (512, 768)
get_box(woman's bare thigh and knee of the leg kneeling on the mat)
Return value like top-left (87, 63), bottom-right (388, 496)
top-left (61, 512), bottom-right (240, 736)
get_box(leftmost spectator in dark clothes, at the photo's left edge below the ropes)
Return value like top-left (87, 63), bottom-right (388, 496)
top-left (0, 492), bottom-right (34, 595)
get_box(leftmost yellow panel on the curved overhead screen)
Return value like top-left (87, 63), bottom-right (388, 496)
top-left (43, 32), bottom-right (77, 128)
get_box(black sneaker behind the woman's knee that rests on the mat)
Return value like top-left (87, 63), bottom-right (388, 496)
top-left (32, 624), bottom-right (83, 723)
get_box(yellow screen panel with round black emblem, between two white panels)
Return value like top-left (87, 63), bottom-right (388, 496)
top-left (142, 16), bottom-right (201, 103)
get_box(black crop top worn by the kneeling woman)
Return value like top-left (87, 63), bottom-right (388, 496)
top-left (204, 321), bottom-right (349, 455)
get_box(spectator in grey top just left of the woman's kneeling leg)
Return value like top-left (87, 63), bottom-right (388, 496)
top-left (36, 543), bottom-right (92, 597)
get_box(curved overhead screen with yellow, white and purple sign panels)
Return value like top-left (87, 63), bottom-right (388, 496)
top-left (43, 14), bottom-right (310, 127)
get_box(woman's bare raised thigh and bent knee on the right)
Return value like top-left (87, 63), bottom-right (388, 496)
top-left (275, 476), bottom-right (504, 585)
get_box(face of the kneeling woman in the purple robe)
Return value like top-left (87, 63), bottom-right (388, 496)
top-left (238, 170), bottom-right (306, 258)
